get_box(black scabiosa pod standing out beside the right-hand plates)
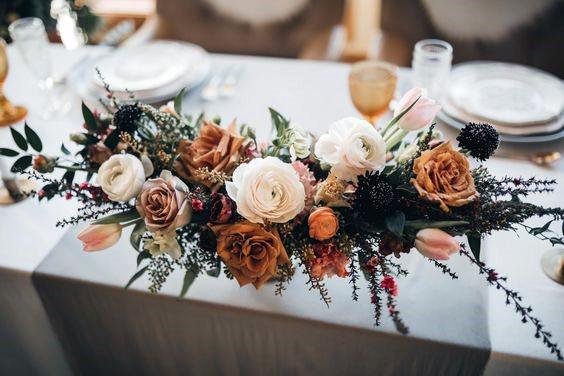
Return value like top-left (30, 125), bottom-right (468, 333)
top-left (456, 123), bottom-right (499, 161)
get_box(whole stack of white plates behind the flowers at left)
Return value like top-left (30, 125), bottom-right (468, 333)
top-left (72, 41), bottom-right (210, 103)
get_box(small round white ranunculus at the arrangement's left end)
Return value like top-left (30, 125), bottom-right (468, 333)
top-left (97, 154), bottom-right (145, 201)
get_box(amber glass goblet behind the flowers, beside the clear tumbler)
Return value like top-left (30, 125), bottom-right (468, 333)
top-left (349, 61), bottom-right (397, 126)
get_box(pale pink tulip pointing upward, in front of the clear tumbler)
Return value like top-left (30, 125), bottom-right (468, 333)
top-left (394, 87), bottom-right (441, 131)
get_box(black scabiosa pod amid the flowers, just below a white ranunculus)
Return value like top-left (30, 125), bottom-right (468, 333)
top-left (354, 172), bottom-right (397, 222)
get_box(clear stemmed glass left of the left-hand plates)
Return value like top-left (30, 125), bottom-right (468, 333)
top-left (8, 17), bottom-right (70, 119)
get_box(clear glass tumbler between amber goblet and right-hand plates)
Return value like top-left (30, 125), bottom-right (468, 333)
top-left (411, 39), bottom-right (452, 100)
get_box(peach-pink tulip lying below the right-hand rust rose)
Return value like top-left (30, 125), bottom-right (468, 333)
top-left (415, 228), bottom-right (460, 260)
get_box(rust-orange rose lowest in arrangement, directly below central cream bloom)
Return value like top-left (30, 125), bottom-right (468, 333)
top-left (211, 221), bottom-right (290, 289)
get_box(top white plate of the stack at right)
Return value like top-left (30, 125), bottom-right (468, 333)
top-left (447, 62), bottom-right (564, 126)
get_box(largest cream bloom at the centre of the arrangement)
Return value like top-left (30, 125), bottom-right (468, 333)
top-left (225, 157), bottom-right (305, 223)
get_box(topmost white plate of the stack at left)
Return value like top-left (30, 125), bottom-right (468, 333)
top-left (94, 41), bottom-right (205, 92)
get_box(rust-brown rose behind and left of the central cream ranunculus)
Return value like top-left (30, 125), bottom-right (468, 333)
top-left (174, 121), bottom-right (244, 188)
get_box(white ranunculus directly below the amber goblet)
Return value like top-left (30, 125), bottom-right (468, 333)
top-left (315, 117), bottom-right (386, 182)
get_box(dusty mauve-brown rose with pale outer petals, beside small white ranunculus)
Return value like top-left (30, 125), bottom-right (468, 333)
top-left (136, 170), bottom-right (192, 233)
